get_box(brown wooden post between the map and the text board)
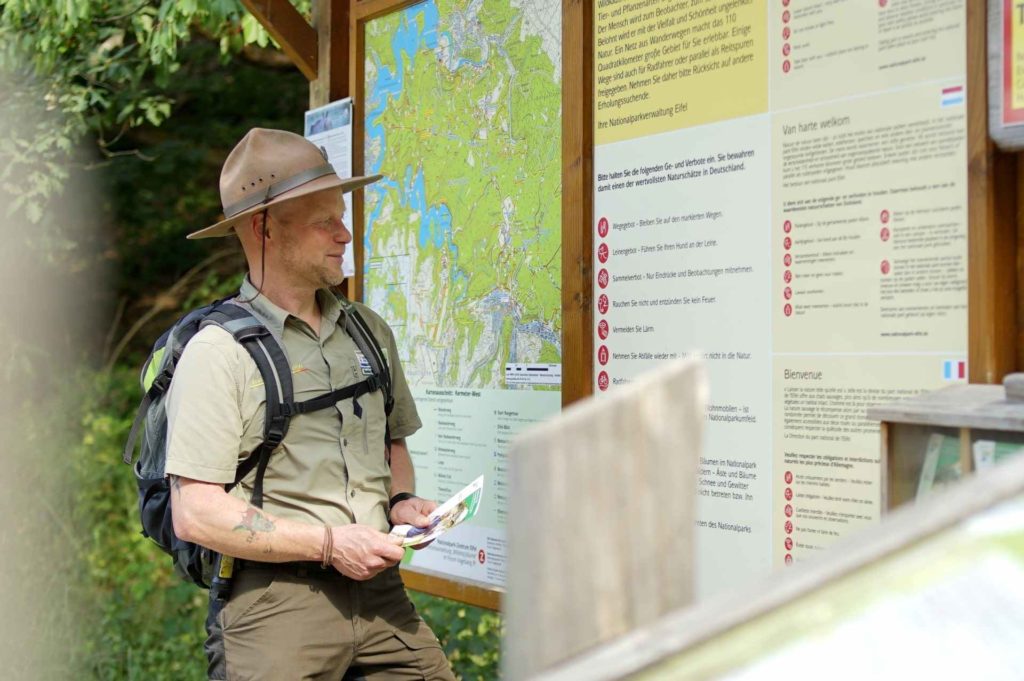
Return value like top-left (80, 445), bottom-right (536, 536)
top-left (562, 0), bottom-right (595, 407)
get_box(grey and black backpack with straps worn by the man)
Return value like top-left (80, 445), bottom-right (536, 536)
top-left (123, 296), bottom-right (394, 588)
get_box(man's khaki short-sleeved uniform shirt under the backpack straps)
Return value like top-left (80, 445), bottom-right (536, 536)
top-left (166, 280), bottom-right (422, 531)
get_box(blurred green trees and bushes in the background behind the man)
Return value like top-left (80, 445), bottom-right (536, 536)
top-left (0, 0), bottom-right (503, 680)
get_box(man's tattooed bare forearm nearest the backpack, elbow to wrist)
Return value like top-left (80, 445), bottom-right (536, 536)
top-left (171, 476), bottom-right (324, 562)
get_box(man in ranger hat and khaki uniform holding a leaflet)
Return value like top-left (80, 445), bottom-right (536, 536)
top-left (166, 128), bottom-right (453, 680)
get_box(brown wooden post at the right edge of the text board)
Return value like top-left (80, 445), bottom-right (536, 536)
top-left (967, 2), bottom-right (1017, 383)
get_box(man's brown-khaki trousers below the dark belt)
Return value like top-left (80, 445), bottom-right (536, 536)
top-left (206, 565), bottom-right (455, 681)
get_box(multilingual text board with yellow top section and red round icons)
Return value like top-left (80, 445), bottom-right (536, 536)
top-left (593, 0), bottom-right (968, 596)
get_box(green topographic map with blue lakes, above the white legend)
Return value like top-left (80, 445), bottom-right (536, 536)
top-left (364, 0), bottom-right (561, 389)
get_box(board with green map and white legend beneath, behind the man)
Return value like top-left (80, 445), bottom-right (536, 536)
top-left (362, 0), bottom-right (562, 587)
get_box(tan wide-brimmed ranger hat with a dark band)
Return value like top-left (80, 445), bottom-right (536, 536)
top-left (188, 128), bottom-right (381, 239)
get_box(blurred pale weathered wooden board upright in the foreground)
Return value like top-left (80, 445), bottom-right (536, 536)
top-left (504, 360), bottom-right (707, 679)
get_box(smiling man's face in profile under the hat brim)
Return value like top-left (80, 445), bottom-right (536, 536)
top-left (270, 190), bottom-right (352, 289)
